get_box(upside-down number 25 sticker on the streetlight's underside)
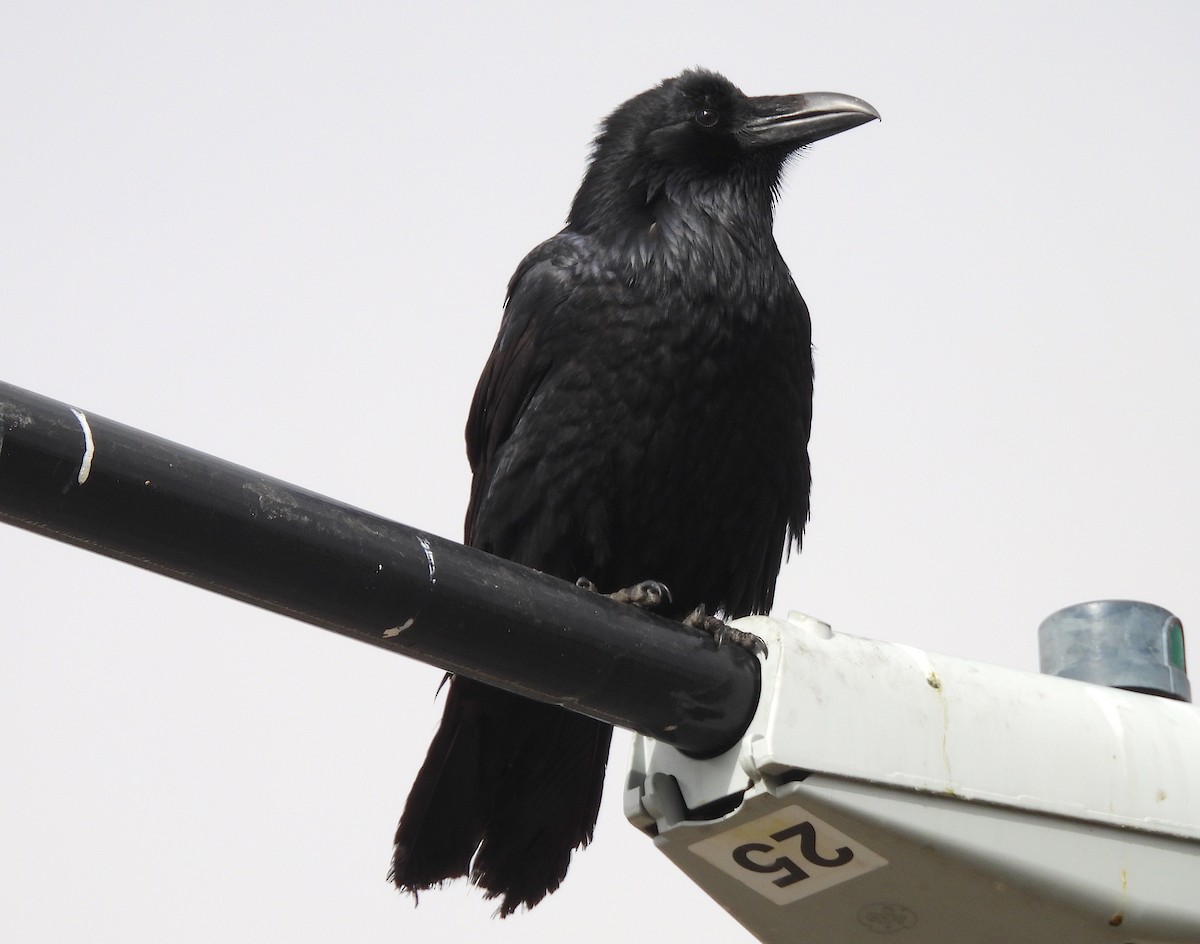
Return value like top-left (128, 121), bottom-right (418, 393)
top-left (690, 806), bottom-right (888, 904)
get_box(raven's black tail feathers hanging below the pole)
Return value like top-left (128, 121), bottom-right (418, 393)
top-left (389, 678), bottom-right (612, 918)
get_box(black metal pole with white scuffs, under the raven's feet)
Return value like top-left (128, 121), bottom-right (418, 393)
top-left (0, 383), bottom-right (761, 754)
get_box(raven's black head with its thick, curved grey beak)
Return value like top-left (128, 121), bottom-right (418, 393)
top-left (568, 70), bottom-right (880, 233)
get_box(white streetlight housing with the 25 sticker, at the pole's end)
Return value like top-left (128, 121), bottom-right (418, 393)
top-left (625, 613), bottom-right (1200, 944)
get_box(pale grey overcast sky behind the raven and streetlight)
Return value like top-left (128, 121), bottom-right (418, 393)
top-left (0, 0), bottom-right (1200, 944)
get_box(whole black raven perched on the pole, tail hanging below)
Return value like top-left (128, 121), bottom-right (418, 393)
top-left (391, 70), bottom-right (878, 916)
